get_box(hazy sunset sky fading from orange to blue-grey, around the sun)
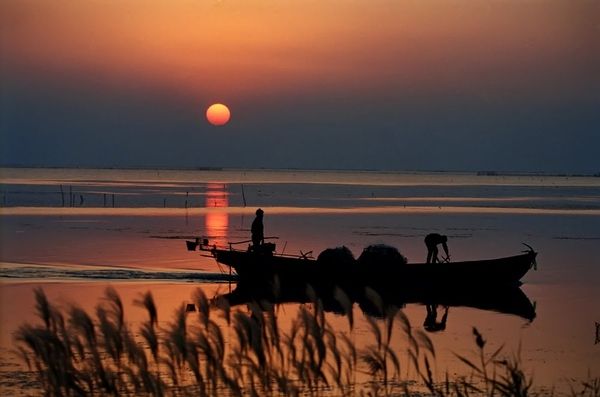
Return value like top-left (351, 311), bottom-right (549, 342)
top-left (0, 0), bottom-right (600, 173)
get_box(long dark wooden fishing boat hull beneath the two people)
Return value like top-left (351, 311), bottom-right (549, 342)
top-left (188, 240), bottom-right (537, 289)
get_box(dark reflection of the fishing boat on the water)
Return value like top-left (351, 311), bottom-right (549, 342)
top-left (216, 281), bottom-right (536, 332)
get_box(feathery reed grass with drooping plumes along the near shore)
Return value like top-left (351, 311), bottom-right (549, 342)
top-left (15, 288), bottom-right (600, 396)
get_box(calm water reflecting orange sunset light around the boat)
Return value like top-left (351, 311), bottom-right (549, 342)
top-left (0, 169), bottom-right (600, 391)
